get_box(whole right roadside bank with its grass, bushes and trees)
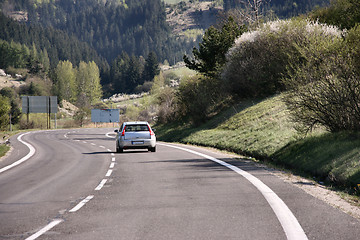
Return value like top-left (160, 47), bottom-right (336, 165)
top-left (157, 0), bottom-right (360, 193)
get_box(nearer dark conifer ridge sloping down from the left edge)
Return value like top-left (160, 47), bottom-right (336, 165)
top-left (0, 12), bottom-right (108, 69)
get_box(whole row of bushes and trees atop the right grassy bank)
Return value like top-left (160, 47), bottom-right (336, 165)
top-left (159, 13), bottom-right (360, 132)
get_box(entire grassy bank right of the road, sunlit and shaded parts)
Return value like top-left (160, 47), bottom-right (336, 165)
top-left (156, 93), bottom-right (360, 193)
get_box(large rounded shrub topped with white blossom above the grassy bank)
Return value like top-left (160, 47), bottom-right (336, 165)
top-left (222, 20), bottom-right (343, 97)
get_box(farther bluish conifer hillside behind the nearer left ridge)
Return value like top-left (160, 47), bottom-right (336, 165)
top-left (2, 0), bottom-right (193, 63)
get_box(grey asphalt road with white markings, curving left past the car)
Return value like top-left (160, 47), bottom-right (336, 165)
top-left (0, 129), bottom-right (360, 240)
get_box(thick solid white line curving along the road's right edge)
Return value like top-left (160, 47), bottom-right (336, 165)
top-left (160, 144), bottom-right (308, 240)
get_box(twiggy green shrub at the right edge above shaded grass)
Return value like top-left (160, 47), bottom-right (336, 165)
top-left (284, 21), bottom-right (360, 132)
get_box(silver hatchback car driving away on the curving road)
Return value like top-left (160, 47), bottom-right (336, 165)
top-left (115, 122), bottom-right (156, 153)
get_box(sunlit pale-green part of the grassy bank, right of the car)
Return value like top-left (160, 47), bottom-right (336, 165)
top-left (158, 96), bottom-right (299, 158)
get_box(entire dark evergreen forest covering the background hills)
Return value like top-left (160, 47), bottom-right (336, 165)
top-left (0, 0), bottom-right (328, 96)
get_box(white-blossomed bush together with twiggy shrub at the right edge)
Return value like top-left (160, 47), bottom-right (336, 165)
top-left (222, 20), bottom-right (360, 132)
